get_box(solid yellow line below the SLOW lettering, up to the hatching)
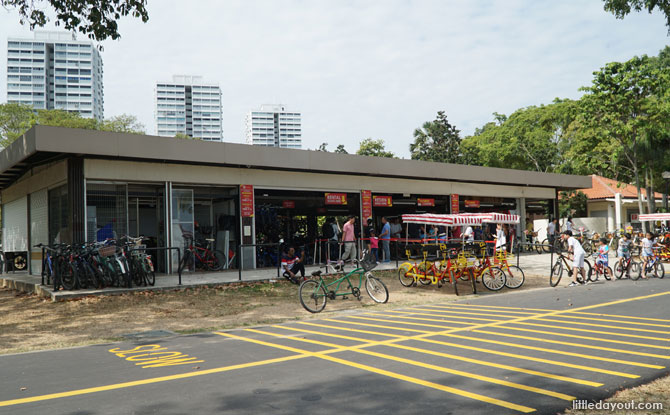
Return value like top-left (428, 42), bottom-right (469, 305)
top-left (0, 354), bottom-right (308, 407)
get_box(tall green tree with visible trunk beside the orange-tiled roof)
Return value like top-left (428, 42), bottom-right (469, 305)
top-left (579, 55), bottom-right (670, 231)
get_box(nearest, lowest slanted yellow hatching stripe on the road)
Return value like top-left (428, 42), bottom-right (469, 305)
top-left (226, 329), bottom-right (535, 413)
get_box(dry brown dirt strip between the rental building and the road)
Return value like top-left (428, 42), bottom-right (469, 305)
top-left (0, 271), bottom-right (548, 354)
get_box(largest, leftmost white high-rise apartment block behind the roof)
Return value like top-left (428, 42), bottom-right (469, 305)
top-left (7, 31), bottom-right (104, 120)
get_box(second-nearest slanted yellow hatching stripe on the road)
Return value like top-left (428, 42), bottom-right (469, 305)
top-left (252, 326), bottom-right (576, 401)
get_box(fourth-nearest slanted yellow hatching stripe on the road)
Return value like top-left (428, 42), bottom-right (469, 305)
top-left (296, 320), bottom-right (639, 379)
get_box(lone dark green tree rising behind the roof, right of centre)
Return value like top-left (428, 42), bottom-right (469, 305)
top-left (409, 111), bottom-right (462, 163)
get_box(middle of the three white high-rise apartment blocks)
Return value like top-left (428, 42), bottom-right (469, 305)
top-left (155, 75), bottom-right (223, 141)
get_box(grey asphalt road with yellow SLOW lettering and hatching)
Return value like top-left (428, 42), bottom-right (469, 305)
top-left (0, 280), bottom-right (670, 415)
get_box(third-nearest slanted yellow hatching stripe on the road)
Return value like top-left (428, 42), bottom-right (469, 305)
top-left (273, 325), bottom-right (603, 387)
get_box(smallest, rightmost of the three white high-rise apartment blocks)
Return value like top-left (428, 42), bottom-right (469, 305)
top-left (246, 104), bottom-right (302, 148)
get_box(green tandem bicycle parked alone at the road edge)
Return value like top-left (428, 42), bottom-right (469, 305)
top-left (298, 258), bottom-right (389, 313)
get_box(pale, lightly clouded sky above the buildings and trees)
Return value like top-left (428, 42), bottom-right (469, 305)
top-left (0, 0), bottom-right (670, 157)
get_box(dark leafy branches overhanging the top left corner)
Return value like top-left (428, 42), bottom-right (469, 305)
top-left (0, 0), bottom-right (149, 42)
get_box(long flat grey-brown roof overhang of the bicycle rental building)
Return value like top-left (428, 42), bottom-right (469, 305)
top-left (0, 125), bottom-right (591, 190)
